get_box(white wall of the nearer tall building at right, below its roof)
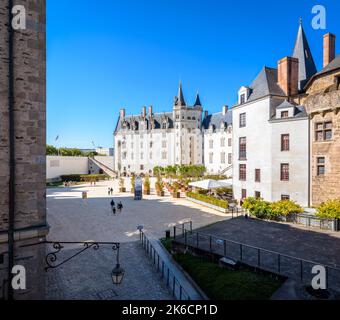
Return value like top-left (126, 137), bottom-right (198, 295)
top-left (233, 97), bottom-right (309, 206)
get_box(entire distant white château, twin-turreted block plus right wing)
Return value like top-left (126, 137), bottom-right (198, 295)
top-left (114, 84), bottom-right (232, 175)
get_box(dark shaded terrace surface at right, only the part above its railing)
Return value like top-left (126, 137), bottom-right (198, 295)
top-left (193, 217), bottom-right (340, 269)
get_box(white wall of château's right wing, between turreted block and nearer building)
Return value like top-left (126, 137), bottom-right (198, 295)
top-left (203, 126), bottom-right (233, 176)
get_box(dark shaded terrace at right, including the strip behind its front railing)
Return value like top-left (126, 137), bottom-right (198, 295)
top-left (176, 217), bottom-right (340, 292)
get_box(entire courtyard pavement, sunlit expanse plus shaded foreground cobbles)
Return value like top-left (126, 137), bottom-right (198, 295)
top-left (47, 181), bottom-right (226, 299)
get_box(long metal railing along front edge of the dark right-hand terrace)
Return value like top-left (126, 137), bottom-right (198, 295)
top-left (173, 221), bottom-right (340, 290)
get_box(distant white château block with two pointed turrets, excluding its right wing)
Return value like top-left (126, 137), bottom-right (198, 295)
top-left (114, 84), bottom-right (203, 174)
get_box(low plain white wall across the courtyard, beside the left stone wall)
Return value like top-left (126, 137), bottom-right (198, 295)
top-left (46, 156), bottom-right (89, 180)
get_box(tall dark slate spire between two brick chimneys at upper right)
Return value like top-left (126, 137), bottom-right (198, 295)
top-left (293, 18), bottom-right (317, 90)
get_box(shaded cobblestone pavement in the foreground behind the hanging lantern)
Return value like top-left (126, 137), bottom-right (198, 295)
top-left (47, 241), bottom-right (172, 300)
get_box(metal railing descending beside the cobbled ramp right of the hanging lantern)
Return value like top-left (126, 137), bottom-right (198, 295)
top-left (140, 231), bottom-right (191, 300)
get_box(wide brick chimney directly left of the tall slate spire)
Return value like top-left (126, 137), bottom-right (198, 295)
top-left (278, 57), bottom-right (299, 96)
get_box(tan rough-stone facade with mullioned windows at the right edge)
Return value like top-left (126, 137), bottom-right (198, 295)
top-left (303, 66), bottom-right (340, 205)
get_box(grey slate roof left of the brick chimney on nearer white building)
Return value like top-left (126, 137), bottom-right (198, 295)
top-left (247, 67), bottom-right (286, 102)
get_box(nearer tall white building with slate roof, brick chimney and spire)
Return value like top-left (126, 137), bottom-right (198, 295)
top-left (233, 25), bottom-right (316, 206)
